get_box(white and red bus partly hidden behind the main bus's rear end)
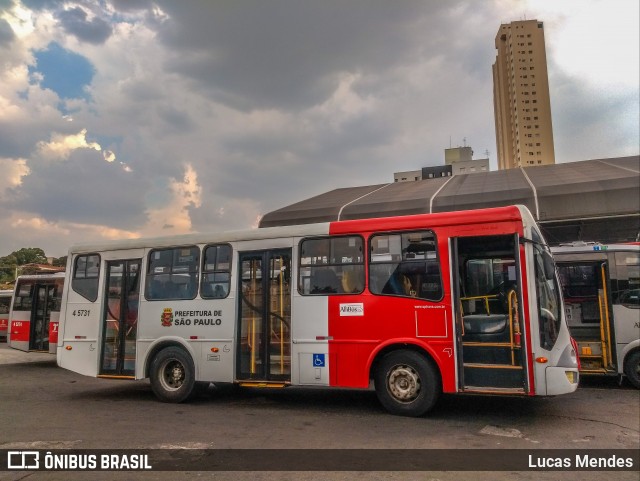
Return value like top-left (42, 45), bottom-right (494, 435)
top-left (7, 272), bottom-right (64, 354)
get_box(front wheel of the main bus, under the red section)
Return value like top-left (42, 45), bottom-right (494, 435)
top-left (374, 351), bottom-right (442, 417)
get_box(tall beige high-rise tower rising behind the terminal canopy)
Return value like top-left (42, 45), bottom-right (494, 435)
top-left (493, 20), bottom-right (555, 169)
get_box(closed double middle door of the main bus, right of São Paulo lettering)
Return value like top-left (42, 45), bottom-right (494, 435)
top-left (236, 249), bottom-right (291, 385)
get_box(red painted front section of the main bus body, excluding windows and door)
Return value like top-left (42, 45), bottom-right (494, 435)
top-left (328, 206), bottom-right (535, 395)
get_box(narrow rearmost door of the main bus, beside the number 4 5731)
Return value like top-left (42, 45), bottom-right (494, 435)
top-left (99, 259), bottom-right (142, 377)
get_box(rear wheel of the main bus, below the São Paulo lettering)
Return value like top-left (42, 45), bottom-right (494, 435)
top-left (149, 347), bottom-right (196, 403)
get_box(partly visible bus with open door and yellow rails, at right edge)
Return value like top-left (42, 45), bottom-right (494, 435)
top-left (552, 242), bottom-right (640, 388)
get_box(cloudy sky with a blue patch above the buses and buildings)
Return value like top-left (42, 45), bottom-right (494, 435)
top-left (0, 0), bottom-right (640, 257)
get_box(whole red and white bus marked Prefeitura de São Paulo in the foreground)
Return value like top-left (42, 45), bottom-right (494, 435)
top-left (57, 206), bottom-right (578, 416)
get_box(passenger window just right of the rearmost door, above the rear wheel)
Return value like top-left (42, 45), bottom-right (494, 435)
top-left (145, 246), bottom-right (200, 300)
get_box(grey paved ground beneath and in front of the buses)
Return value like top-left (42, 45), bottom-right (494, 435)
top-left (0, 345), bottom-right (640, 481)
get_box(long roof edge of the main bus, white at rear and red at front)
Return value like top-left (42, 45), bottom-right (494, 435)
top-left (69, 205), bottom-right (535, 254)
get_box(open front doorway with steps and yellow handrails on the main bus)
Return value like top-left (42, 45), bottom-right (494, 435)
top-left (452, 235), bottom-right (529, 394)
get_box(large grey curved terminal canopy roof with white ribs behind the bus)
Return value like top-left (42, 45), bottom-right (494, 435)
top-left (260, 155), bottom-right (640, 244)
